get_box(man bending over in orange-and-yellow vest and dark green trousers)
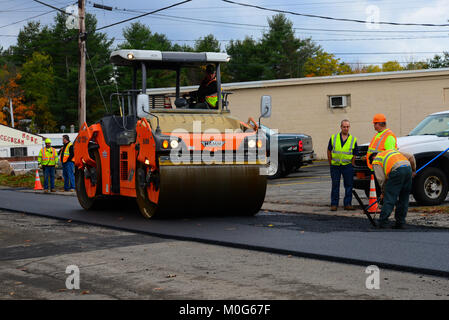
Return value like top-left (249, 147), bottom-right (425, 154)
top-left (369, 150), bottom-right (416, 229)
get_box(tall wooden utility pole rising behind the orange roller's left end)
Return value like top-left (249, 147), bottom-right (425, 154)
top-left (78, 0), bottom-right (86, 129)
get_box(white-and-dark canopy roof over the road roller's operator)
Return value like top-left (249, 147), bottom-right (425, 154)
top-left (111, 49), bottom-right (230, 68)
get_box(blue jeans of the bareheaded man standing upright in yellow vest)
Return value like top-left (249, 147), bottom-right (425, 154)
top-left (330, 164), bottom-right (354, 207)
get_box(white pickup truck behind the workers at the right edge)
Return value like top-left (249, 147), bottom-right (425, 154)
top-left (354, 110), bottom-right (449, 205)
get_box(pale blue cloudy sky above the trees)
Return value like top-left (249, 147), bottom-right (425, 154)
top-left (0, 0), bottom-right (449, 67)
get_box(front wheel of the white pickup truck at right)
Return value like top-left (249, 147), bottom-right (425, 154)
top-left (412, 167), bottom-right (448, 206)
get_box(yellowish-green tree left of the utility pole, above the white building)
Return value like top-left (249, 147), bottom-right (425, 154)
top-left (20, 52), bottom-right (56, 132)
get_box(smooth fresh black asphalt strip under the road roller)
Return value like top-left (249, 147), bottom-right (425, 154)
top-left (0, 186), bottom-right (449, 276)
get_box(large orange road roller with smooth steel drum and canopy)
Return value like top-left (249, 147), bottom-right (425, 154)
top-left (74, 49), bottom-right (271, 218)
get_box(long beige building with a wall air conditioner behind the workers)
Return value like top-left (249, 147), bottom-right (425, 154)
top-left (150, 69), bottom-right (449, 159)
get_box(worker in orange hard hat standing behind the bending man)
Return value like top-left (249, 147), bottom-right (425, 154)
top-left (366, 113), bottom-right (398, 171)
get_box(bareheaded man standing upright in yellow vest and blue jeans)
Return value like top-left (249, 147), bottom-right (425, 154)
top-left (327, 119), bottom-right (358, 211)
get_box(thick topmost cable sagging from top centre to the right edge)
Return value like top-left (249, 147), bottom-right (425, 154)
top-left (221, 0), bottom-right (449, 27)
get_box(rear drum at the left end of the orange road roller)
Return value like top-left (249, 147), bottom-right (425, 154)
top-left (75, 150), bottom-right (102, 210)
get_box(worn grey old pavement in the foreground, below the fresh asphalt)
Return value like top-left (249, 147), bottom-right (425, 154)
top-left (0, 210), bottom-right (449, 300)
